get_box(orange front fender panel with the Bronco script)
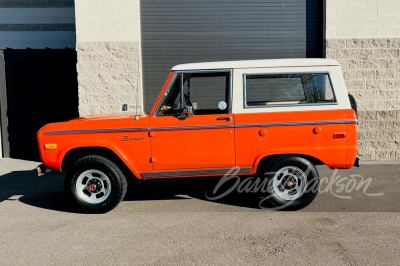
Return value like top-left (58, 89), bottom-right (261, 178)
top-left (38, 116), bottom-right (152, 175)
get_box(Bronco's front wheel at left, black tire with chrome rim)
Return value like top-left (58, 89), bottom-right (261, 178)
top-left (64, 155), bottom-right (127, 213)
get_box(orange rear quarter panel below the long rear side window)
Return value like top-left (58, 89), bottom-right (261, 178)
top-left (235, 110), bottom-right (346, 172)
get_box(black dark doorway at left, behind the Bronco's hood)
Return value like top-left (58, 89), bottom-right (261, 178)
top-left (4, 49), bottom-right (79, 159)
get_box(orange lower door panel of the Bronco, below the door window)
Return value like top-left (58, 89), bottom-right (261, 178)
top-left (150, 114), bottom-right (235, 171)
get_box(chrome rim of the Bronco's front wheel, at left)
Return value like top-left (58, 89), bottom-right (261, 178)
top-left (75, 169), bottom-right (111, 204)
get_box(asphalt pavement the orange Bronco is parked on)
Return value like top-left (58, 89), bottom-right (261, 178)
top-left (0, 159), bottom-right (400, 265)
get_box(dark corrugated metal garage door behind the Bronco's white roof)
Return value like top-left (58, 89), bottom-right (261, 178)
top-left (141, 0), bottom-right (322, 111)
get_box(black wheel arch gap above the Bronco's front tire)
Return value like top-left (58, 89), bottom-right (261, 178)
top-left (61, 146), bottom-right (138, 180)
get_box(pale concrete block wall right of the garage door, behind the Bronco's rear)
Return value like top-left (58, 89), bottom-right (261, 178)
top-left (326, 0), bottom-right (400, 160)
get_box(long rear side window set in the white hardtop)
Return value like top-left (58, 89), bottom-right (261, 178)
top-left (245, 74), bottom-right (336, 107)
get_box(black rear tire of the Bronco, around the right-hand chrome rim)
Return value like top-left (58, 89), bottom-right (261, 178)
top-left (258, 156), bottom-right (319, 210)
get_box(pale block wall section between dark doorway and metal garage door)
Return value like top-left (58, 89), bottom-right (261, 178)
top-left (75, 0), bottom-right (143, 116)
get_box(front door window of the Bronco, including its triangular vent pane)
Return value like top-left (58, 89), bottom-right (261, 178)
top-left (158, 72), bottom-right (230, 116)
